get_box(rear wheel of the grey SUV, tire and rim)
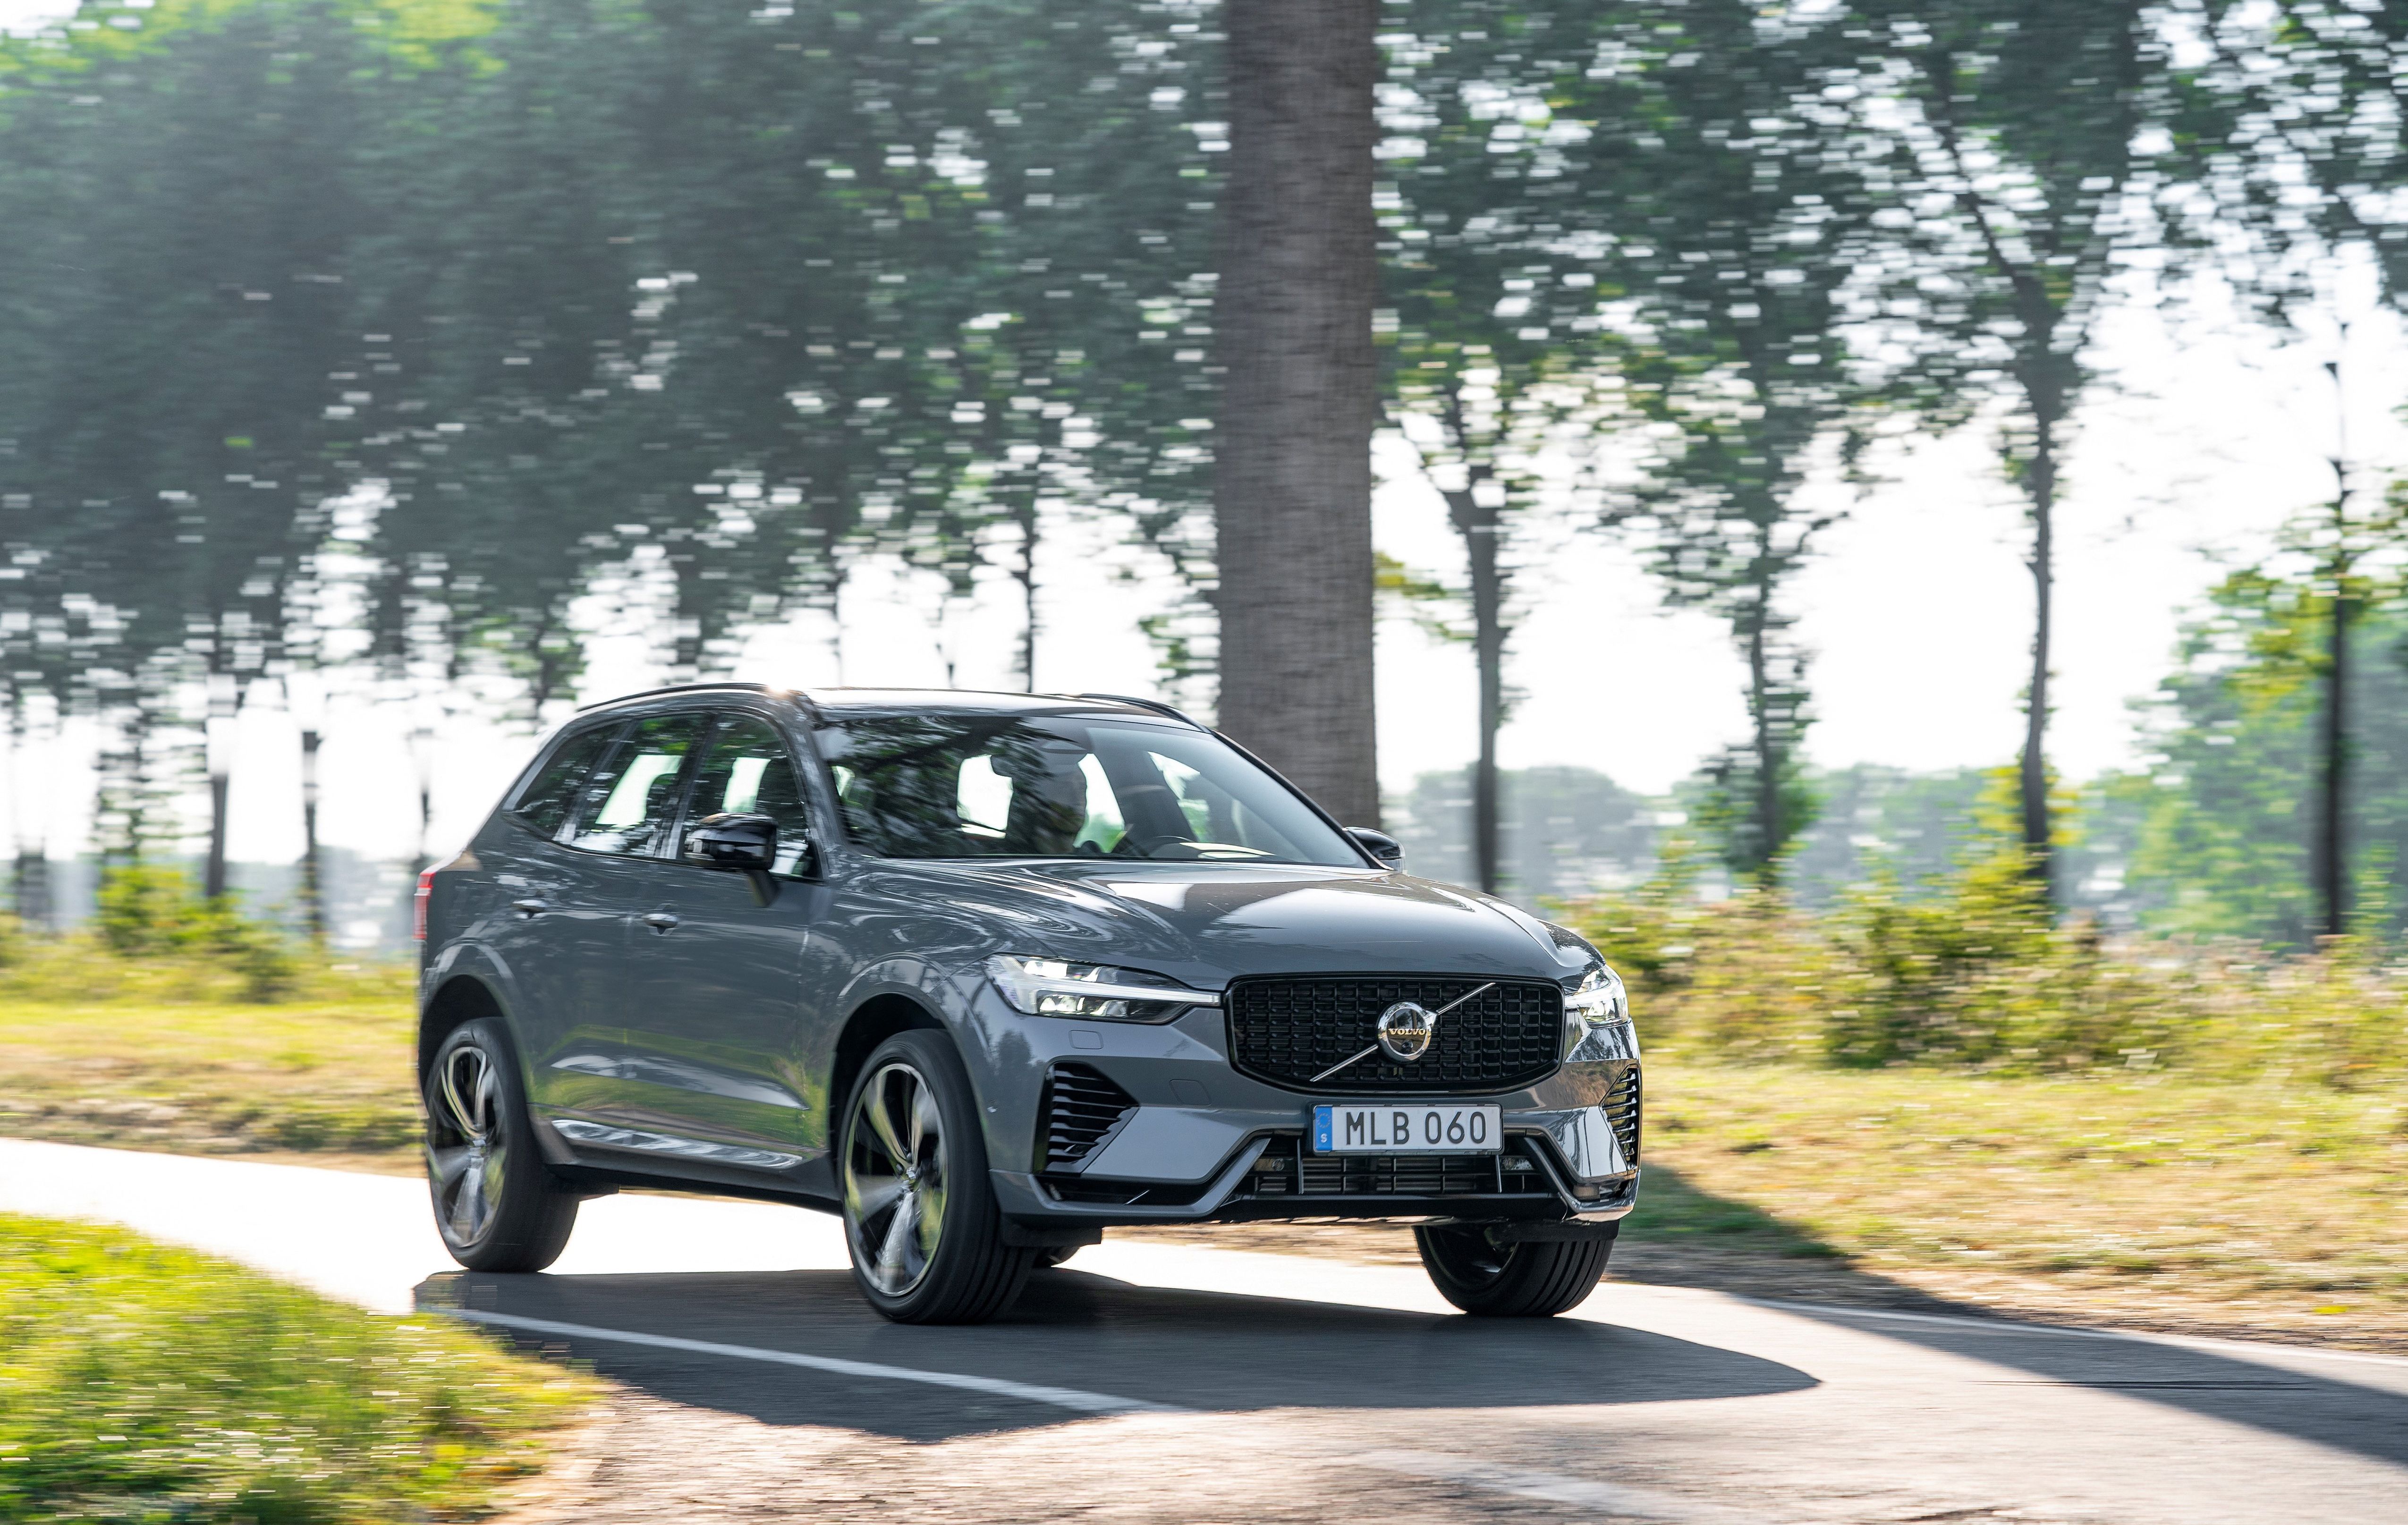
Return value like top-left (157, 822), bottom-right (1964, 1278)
top-left (426, 1017), bottom-right (578, 1272)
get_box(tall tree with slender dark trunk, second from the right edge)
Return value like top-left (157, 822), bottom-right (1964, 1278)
top-left (1825, 0), bottom-right (2198, 906)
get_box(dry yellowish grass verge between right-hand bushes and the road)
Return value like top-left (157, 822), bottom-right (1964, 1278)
top-left (1630, 1055), bottom-right (2408, 1344)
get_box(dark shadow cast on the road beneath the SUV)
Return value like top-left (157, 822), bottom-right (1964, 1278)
top-left (419, 1270), bottom-right (1813, 1440)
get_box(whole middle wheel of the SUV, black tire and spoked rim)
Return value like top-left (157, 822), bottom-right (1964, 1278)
top-left (838, 1031), bottom-right (1043, 1322)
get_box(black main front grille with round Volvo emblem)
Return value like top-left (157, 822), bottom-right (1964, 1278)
top-left (1228, 976), bottom-right (1563, 1094)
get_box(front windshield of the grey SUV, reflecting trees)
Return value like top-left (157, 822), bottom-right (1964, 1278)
top-left (819, 713), bottom-right (1363, 867)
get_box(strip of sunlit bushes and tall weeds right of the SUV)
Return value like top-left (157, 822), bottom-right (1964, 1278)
top-left (1558, 850), bottom-right (2408, 1086)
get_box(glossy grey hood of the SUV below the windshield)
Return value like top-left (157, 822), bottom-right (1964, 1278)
top-left (876, 860), bottom-right (1594, 990)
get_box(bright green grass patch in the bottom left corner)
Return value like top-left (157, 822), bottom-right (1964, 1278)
top-left (0, 1214), bottom-right (595, 1525)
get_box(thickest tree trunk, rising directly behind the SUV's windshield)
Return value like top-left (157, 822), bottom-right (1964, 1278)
top-left (1213, 0), bottom-right (1380, 824)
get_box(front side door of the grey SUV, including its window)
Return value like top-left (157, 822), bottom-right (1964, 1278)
top-left (626, 713), bottom-right (828, 1152)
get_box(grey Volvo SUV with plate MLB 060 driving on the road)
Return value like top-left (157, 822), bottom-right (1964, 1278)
top-left (419, 684), bottom-right (1640, 1322)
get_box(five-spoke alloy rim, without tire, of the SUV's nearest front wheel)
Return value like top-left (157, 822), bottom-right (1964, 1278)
top-left (845, 1062), bottom-right (946, 1296)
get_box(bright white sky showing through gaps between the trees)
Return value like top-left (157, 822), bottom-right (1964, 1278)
top-left (0, 0), bottom-right (2408, 860)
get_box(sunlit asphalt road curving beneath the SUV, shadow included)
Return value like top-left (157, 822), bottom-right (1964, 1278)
top-left (0, 1142), bottom-right (2408, 1525)
